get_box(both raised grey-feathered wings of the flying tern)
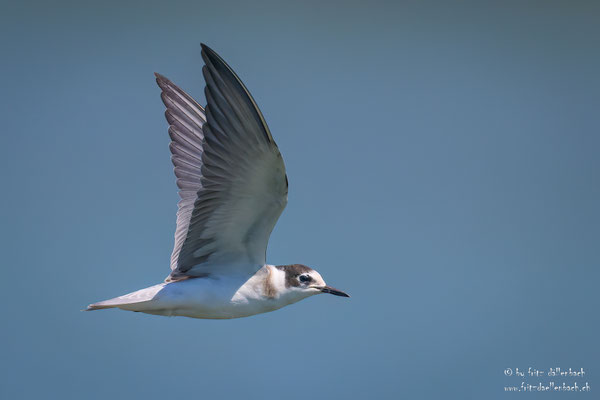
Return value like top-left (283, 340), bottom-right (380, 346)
top-left (156, 45), bottom-right (288, 280)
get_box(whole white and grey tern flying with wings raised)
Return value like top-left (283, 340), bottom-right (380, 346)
top-left (86, 44), bottom-right (350, 319)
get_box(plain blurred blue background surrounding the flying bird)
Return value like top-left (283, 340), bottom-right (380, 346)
top-left (0, 1), bottom-right (600, 399)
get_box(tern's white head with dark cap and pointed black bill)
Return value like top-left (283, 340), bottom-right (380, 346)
top-left (275, 264), bottom-right (350, 297)
